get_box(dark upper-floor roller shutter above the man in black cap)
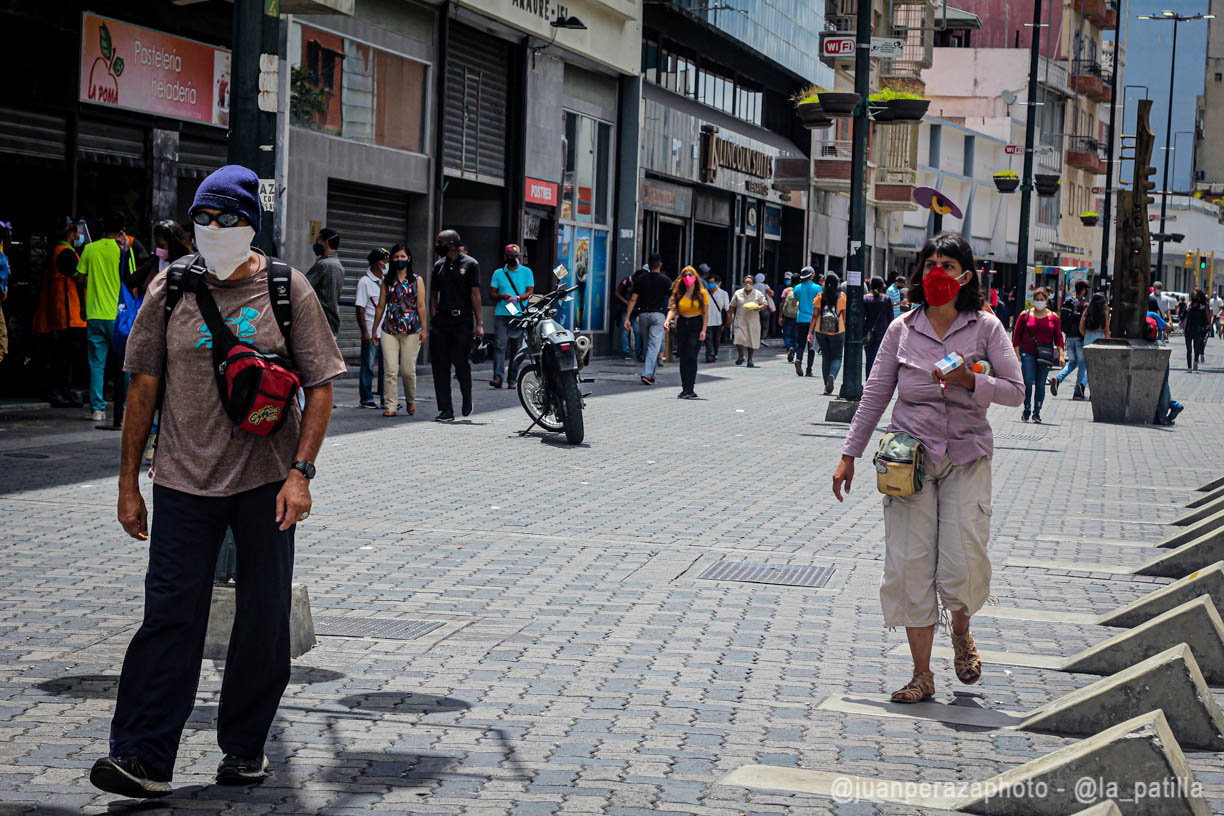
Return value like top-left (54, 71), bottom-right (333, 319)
top-left (442, 23), bottom-right (509, 182)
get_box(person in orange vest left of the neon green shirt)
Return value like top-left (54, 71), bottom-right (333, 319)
top-left (32, 218), bottom-right (86, 407)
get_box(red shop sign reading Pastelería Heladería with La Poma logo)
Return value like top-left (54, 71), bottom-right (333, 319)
top-left (80, 12), bottom-right (230, 127)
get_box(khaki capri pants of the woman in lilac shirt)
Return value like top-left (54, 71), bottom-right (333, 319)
top-left (880, 455), bottom-right (991, 628)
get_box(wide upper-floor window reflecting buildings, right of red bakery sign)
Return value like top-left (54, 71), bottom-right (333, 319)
top-left (289, 23), bottom-right (426, 152)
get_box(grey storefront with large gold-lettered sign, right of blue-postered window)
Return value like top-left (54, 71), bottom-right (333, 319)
top-left (638, 91), bottom-right (805, 286)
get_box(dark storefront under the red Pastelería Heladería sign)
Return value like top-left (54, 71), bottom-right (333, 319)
top-left (0, 1), bottom-right (230, 396)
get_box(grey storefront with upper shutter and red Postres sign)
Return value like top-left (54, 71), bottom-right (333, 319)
top-left (441, 0), bottom-right (641, 347)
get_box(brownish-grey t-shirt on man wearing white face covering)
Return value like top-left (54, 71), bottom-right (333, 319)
top-left (124, 260), bottom-right (345, 495)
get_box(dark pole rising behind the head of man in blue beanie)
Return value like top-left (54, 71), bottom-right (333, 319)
top-left (228, 0), bottom-right (280, 254)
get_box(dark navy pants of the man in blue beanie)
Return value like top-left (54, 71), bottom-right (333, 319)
top-left (110, 482), bottom-right (295, 779)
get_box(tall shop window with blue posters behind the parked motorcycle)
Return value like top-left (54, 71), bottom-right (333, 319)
top-left (557, 111), bottom-right (613, 332)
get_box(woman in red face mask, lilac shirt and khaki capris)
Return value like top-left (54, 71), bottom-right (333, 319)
top-left (834, 232), bottom-right (1022, 703)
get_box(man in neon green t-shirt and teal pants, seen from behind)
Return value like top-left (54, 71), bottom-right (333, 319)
top-left (77, 213), bottom-right (136, 422)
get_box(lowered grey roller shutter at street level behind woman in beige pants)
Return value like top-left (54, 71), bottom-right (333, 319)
top-left (324, 179), bottom-right (411, 357)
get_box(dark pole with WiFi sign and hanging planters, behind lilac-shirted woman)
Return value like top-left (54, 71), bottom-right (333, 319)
top-left (825, 0), bottom-right (871, 422)
